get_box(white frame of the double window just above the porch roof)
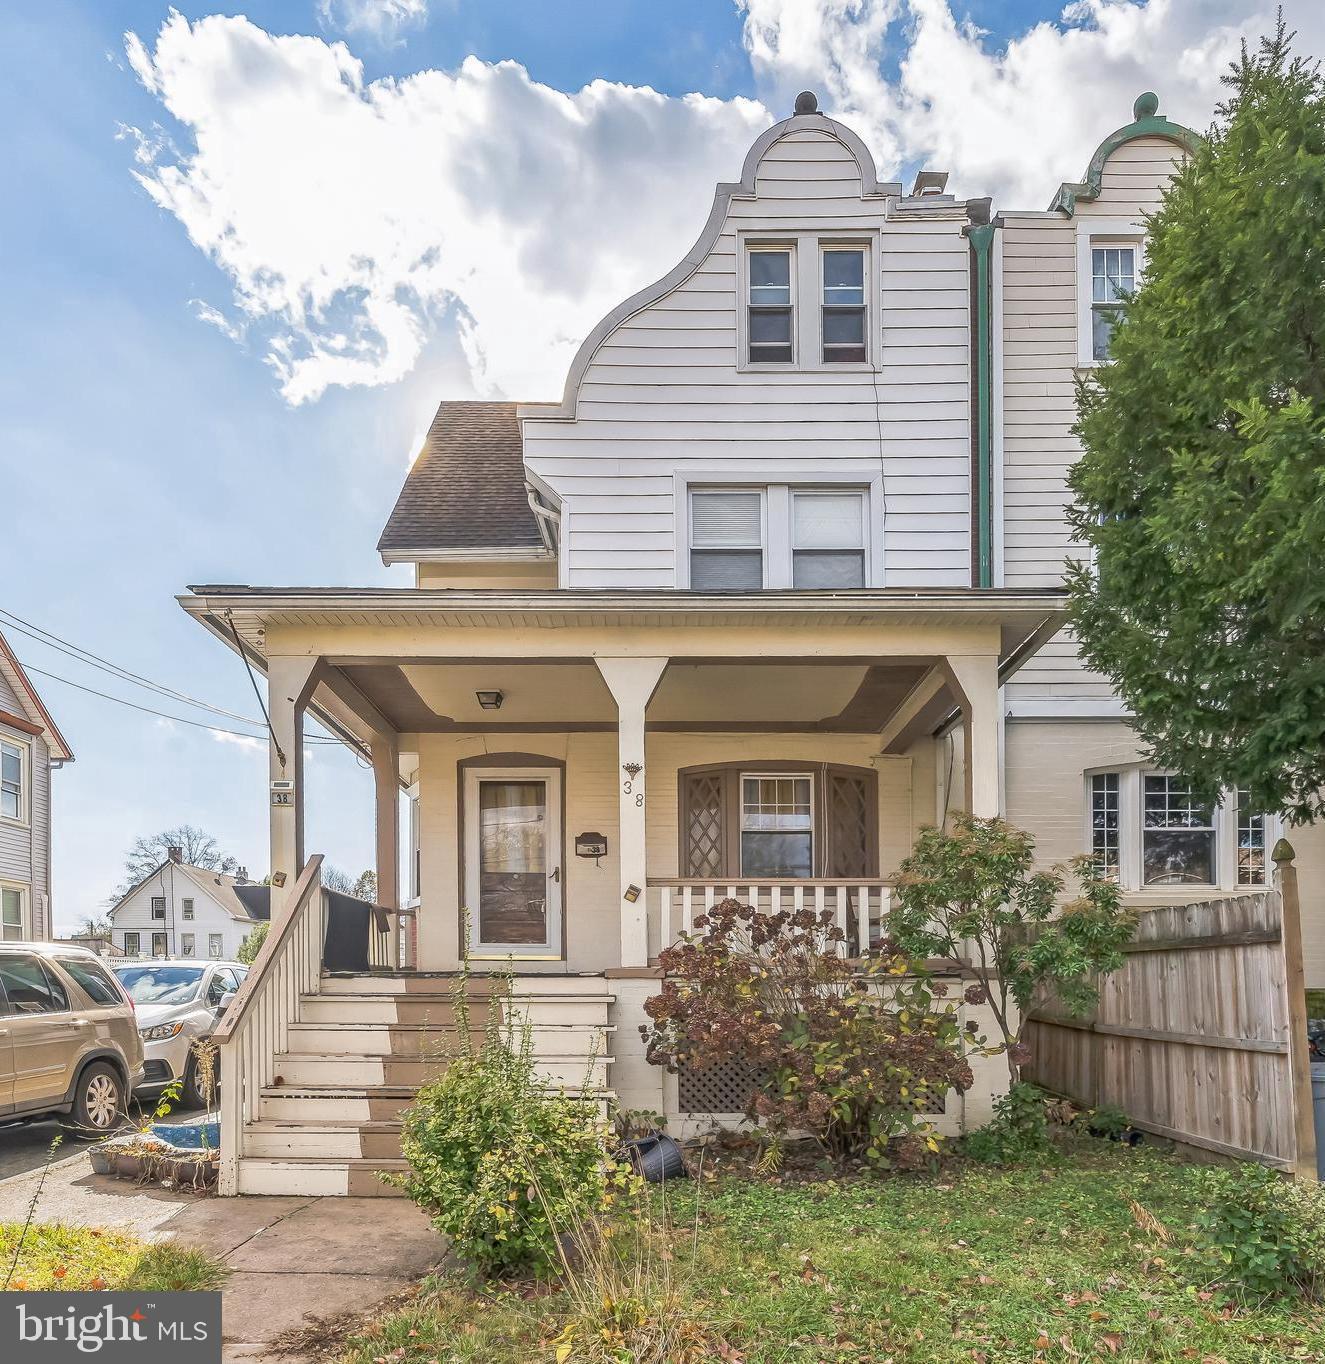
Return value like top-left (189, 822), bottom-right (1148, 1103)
top-left (671, 466), bottom-right (884, 589)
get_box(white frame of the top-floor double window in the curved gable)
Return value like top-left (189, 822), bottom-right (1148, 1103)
top-left (736, 231), bottom-right (883, 374)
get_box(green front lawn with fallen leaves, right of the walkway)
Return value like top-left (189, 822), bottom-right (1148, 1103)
top-left (339, 1138), bottom-right (1325, 1364)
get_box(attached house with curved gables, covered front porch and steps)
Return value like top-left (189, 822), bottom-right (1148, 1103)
top-left (180, 94), bottom-right (1282, 1192)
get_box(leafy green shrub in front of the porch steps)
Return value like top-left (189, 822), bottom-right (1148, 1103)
top-left (393, 996), bottom-right (635, 1277)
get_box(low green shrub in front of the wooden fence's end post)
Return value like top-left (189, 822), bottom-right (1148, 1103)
top-left (1197, 1165), bottom-right (1325, 1300)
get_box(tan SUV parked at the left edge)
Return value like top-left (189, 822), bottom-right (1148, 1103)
top-left (0, 943), bottom-right (143, 1136)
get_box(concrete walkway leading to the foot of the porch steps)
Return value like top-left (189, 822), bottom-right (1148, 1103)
top-left (0, 1148), bottom-right (443, 1364)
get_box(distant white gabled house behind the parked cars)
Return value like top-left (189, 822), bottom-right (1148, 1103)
top-left (108, 848), bottom-right (270, 962)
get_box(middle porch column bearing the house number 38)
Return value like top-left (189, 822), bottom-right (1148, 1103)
top-left (595, 659), bottom-right (667, 966)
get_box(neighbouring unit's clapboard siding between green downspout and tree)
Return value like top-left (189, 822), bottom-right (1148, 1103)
top-left (999, 138), bottom-right (1179, 711)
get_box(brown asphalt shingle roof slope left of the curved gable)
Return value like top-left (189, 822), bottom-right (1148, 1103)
top-left (377, 402), bottom-right (543, 552)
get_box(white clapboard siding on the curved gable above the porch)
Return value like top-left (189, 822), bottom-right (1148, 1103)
top-left (524, 128), bottom-right (970, 588)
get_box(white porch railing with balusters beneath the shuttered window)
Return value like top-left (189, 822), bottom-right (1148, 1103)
top-left (648, 877), bottom-right (892, 962)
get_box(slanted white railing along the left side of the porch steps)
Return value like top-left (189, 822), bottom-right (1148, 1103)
top-left (212, 854), bottom-right (326, 1194)
